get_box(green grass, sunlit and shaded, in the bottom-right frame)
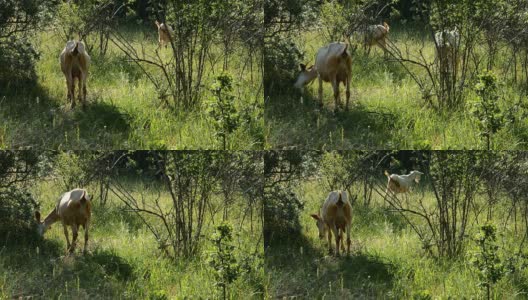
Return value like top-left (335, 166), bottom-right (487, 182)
top-left (265, 181), bottom-right (528, 299)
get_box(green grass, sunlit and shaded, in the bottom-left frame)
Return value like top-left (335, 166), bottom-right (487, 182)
top-left (0, 179), bottom-right (264, 299)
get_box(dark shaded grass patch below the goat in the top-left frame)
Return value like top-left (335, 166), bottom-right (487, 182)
top-left (0, 80), bottom-right (131, 149)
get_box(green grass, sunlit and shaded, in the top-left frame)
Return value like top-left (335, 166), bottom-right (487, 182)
top-left (0, 26), bottom-right (263, 149)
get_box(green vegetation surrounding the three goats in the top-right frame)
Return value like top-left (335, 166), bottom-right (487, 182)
top-left (264, 0), bottom-right (528, 150)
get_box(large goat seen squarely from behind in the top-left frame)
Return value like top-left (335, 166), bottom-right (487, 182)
top-left (59, 41), bottom-right (90, 108)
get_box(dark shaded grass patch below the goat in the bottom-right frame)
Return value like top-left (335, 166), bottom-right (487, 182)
top-left (265, 230), bottom-right (394, 298)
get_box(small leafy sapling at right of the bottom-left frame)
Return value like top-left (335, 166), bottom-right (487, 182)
top-left (209, 223), bottom-right (240, 299)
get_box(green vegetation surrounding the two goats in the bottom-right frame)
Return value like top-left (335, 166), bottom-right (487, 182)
top-left (264, 151), bottom-right (528, 299)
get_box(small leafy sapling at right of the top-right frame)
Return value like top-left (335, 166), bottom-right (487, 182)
top-left (473, 71), bottom-right (504, 150)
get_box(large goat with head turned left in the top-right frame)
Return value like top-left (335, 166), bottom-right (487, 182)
top-left (294, 42), bottom-right (352, 111)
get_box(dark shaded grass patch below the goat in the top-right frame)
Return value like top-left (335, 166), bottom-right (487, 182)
top-left (266, 90), bottom-right (399, 149)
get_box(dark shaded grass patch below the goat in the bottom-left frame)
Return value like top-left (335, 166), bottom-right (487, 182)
top-left (0, 232), bottom-right (135, 298)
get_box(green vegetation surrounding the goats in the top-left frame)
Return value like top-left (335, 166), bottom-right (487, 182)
top-left (0, 0), bottom-right (263, 149)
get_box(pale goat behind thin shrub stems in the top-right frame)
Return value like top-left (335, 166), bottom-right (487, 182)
top-left (434, 27), bottom-right (460, 72)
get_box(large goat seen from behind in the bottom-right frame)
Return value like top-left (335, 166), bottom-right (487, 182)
top-left (311, 191), bottom-right (352, 256)
